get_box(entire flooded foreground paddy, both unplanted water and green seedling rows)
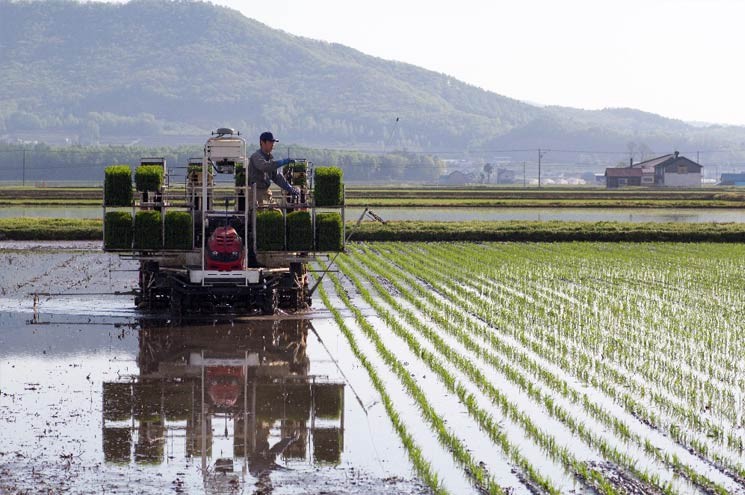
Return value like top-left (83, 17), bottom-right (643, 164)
top-left (0, 243), bottom-right (745, 494)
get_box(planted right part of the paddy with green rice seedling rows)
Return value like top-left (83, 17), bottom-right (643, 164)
top-left (324, 243), bottom-right (745, 493)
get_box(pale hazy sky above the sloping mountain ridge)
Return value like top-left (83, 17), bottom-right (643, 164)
top-left (201, 0), bottom-right (745, 124)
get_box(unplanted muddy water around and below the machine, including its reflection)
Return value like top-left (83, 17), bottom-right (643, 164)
top-left (0, 244), bottom-right (428, 494)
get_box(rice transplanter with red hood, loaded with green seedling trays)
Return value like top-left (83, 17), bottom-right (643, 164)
top-left (104, 128), bottom-right (344, 315)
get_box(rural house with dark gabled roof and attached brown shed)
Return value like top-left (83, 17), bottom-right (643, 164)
top-left (605, 151), bottom-right (703, 189)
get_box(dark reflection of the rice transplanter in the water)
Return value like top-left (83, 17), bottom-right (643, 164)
top-left (103, 320), bottom-right (344, 492)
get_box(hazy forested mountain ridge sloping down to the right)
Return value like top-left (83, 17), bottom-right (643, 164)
top-left (0, 0), bottom-right (745, 164)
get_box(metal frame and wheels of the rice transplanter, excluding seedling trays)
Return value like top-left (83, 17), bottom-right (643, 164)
top-left (104, 128), bottom-right (344, 316)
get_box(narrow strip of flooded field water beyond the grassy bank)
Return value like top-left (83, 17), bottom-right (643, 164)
top-left (0, 206), bottom-right (745, 223)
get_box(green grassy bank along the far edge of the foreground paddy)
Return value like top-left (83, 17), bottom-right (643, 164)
top-left (0, 218), bottom-right (745, 242)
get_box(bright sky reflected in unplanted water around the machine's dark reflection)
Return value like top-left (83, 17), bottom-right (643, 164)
top-left (0, 316), bottom-right (412, 493)
